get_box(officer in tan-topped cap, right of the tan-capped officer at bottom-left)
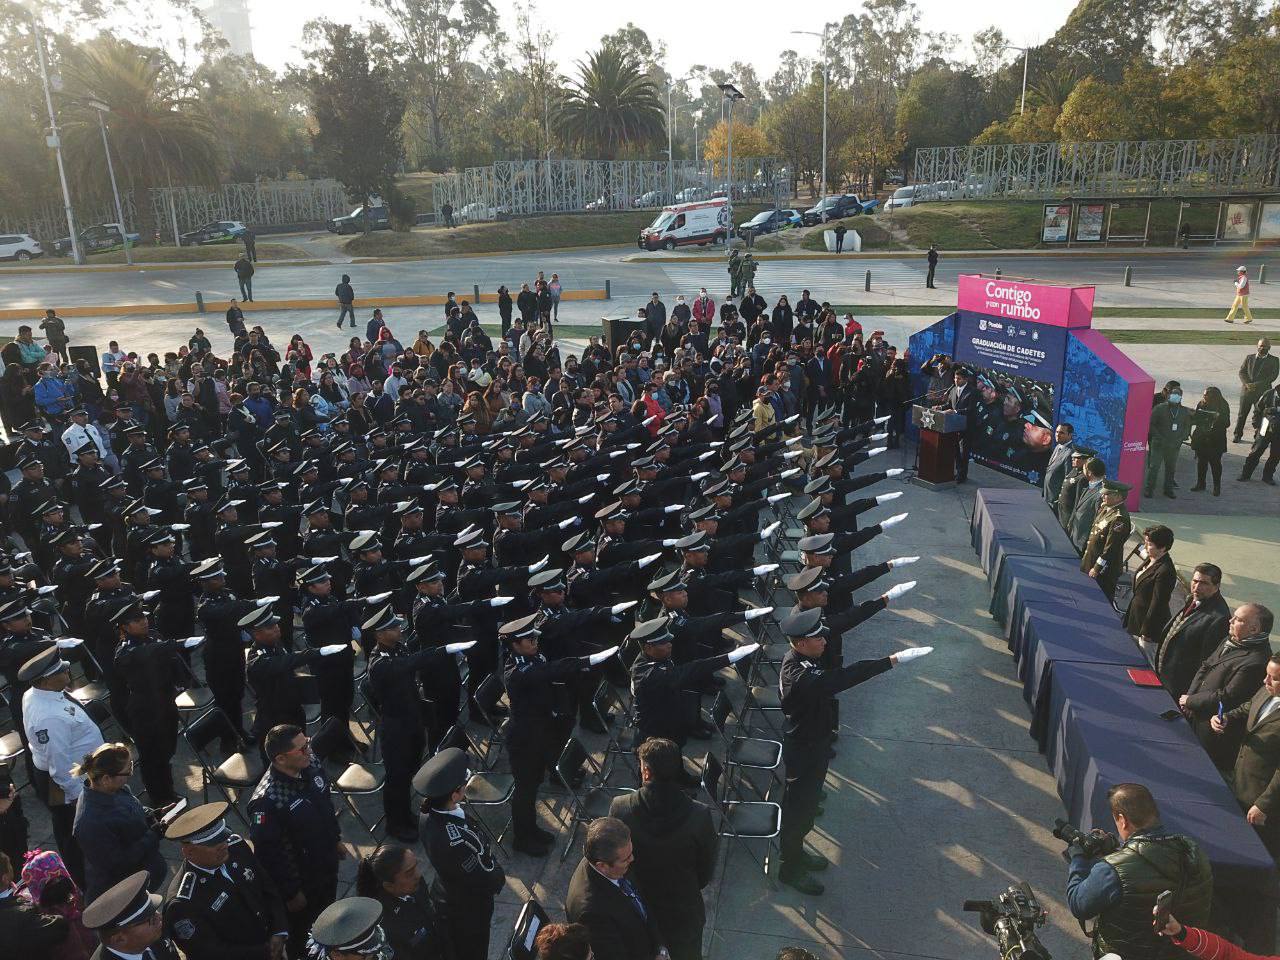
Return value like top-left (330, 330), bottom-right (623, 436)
top-left (164, 803), bottom-right (289, 960)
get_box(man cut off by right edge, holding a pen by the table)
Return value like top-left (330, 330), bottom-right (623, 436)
top-left (1210, 654), bottom-right (1280, 858)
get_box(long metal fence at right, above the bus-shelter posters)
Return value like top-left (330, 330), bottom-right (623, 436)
top-left (914, 134), bottom-right (1280, 200)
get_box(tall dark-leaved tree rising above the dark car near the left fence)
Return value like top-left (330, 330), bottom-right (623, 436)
top-left (306, 23), bottom-right (404, 232)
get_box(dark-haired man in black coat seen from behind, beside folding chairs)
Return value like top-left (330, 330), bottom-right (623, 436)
top-left (609, 737), bottom-right (719, 960)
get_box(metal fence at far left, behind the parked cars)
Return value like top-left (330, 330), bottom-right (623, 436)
top-left (0, 180), bottom-right (352, 243)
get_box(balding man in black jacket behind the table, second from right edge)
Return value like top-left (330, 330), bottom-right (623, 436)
top-left (1178, 603), bottom-right (1275, 780)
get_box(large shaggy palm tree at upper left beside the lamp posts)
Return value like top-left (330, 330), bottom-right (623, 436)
top-left (61, 36), bottom-right (221, 244)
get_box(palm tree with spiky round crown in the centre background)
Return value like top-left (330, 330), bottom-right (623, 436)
top-left (556, 46), bottom-right (666, 160)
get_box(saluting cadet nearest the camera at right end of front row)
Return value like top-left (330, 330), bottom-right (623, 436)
top-left (778, 609), bottom-right (933, 895)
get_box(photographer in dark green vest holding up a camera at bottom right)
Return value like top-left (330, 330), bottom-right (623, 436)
top-left (1066, 783), bottom-right (1213, 960)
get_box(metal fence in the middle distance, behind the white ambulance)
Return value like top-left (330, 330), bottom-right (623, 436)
top-left (431, 157), bottom-right (790, 223)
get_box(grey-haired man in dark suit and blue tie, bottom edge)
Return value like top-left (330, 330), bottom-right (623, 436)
top-left (564, 817), bottom-right (667, 960)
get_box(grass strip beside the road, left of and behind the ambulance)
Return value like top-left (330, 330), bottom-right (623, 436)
top-left (343, 206), bottom-right (763, 257)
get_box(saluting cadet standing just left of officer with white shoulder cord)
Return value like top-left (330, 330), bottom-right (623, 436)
top-left (361, 604), bottom-right (475, 844)
